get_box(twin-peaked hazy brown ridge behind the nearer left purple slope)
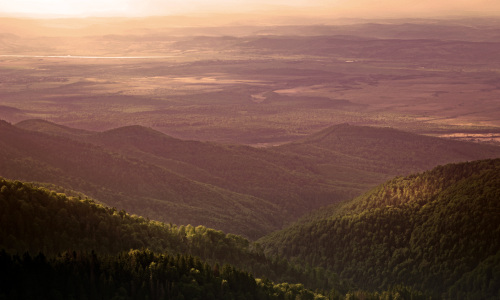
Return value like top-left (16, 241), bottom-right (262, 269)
top-left (16, 120), bottom-right (500, 199)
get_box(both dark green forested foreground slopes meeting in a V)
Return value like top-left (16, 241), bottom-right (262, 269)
top-left (0, 159), bottom-right (500, 299)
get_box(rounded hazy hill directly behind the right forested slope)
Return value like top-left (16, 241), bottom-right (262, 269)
top-left (277, 124), bottom-right (500, 182)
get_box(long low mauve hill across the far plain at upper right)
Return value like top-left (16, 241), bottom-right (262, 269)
top-left (237, 33), bottom-right (499, 62)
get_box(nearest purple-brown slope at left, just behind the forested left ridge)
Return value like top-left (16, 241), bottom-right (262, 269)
top-left (0, 122), bottom-right (280, 237)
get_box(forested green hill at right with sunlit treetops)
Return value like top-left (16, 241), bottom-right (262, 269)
top-left (259, 159), bottom-right (500, 299)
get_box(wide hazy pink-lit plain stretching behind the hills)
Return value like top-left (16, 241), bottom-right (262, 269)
top-left (0, 18), bottom-right (500, 146)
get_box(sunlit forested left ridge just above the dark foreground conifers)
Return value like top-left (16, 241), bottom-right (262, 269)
top-left (0, 179), bottom-right (342, 290)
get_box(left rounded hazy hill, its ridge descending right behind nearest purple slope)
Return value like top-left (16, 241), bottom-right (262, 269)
top-left (16, 120), bottom-right (353, 216)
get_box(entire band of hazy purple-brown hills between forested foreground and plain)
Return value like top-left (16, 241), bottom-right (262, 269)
top-left (0, 120), bottom-right (500, 238)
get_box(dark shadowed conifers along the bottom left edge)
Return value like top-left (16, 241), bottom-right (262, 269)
top-left (0, 250), bottom-right (324, 300)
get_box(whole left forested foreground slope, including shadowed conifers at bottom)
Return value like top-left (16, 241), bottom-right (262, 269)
top-left (0, 179), bottom-right (426, 300)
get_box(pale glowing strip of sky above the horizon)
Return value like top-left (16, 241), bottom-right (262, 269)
top-left (0, 0), bottom-right (500, 17)
